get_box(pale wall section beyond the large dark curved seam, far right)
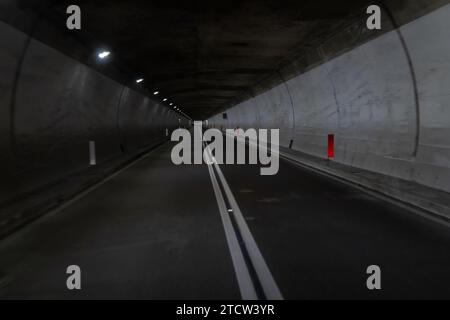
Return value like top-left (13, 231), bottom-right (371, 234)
top-left (402, 5), bottom-right (450, 191)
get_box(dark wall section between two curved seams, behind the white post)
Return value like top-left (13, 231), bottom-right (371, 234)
top-left (13, 40), bottom-right (122, 189)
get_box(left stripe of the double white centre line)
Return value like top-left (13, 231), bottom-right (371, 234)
top-left (207, 145), bottom-right (258, 300)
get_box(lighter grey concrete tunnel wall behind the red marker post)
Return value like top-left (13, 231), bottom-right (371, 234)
top-left (208, 5), bottom-right (450, 192)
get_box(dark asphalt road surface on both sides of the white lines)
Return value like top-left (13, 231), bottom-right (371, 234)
top-left (0, 138), bottom-right (450, 299)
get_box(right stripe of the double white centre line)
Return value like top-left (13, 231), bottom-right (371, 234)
top-left (206, 146), bottom-right (283, 300)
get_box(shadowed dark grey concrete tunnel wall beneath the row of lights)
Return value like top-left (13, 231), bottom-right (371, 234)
top-left (0, 22), bottom-right (185, 208)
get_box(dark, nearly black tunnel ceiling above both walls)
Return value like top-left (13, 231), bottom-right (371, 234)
top-left (16, 0), bottom-right (376, 119)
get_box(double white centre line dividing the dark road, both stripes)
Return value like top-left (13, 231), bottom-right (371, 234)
top-left (204, 140), bottom-right (283, 300)
